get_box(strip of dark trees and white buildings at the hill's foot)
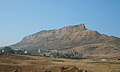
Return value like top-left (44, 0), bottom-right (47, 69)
top-left (0, 47), bottom-right (83, 59)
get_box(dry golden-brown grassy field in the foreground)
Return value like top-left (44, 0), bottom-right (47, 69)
top-left (0, 55), bottom-right (120, 72)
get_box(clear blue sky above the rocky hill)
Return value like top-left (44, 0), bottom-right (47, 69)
top-left (0, 0), bottom-right (120, 47)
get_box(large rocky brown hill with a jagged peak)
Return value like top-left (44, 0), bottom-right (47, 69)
top-left (11, 24), bottom-right (120, 55)
